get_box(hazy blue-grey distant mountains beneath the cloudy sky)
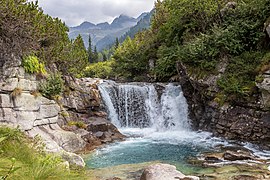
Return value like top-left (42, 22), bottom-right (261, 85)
top-left (69, 13), bottom-right (150, 51)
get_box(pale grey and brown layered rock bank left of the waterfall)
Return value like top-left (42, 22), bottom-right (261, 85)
top-left (0, 56), bottom-right (124, 166)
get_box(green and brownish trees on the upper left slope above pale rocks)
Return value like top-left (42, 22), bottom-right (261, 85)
top-left (0, 0), bottom-right (88, 75)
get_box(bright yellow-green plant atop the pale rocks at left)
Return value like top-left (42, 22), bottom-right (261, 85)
top-left (22, 56), bottom-right (46, 74)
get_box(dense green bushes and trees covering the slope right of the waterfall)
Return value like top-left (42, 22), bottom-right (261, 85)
top-left (86, 0), bottom-right (270, 102)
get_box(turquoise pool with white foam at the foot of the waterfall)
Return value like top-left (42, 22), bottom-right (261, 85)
top-left (86, 128), bottom-right (226, 174)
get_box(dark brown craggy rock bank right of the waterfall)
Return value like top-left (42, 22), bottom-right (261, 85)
top-left (178, 59), bottom-right (270, 148)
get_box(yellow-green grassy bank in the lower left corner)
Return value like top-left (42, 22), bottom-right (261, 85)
top-left (0, 127), bottom-right (86, 180)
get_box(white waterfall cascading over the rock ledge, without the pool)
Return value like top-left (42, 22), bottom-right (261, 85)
top-left (98, 82), bottom-right (190, 131)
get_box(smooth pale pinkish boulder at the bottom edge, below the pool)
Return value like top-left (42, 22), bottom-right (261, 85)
top-left (140, 163), bottom-right (199, 180)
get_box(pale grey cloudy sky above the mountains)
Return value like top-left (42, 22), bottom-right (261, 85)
top-left (34, 0), bottom-right (155, 26)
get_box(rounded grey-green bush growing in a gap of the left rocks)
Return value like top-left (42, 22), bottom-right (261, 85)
top-left (39, 73), bottom-right (64, 98)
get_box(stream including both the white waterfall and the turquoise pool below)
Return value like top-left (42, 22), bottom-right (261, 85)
top-left (86, 81), bottom-right (268, 179)
